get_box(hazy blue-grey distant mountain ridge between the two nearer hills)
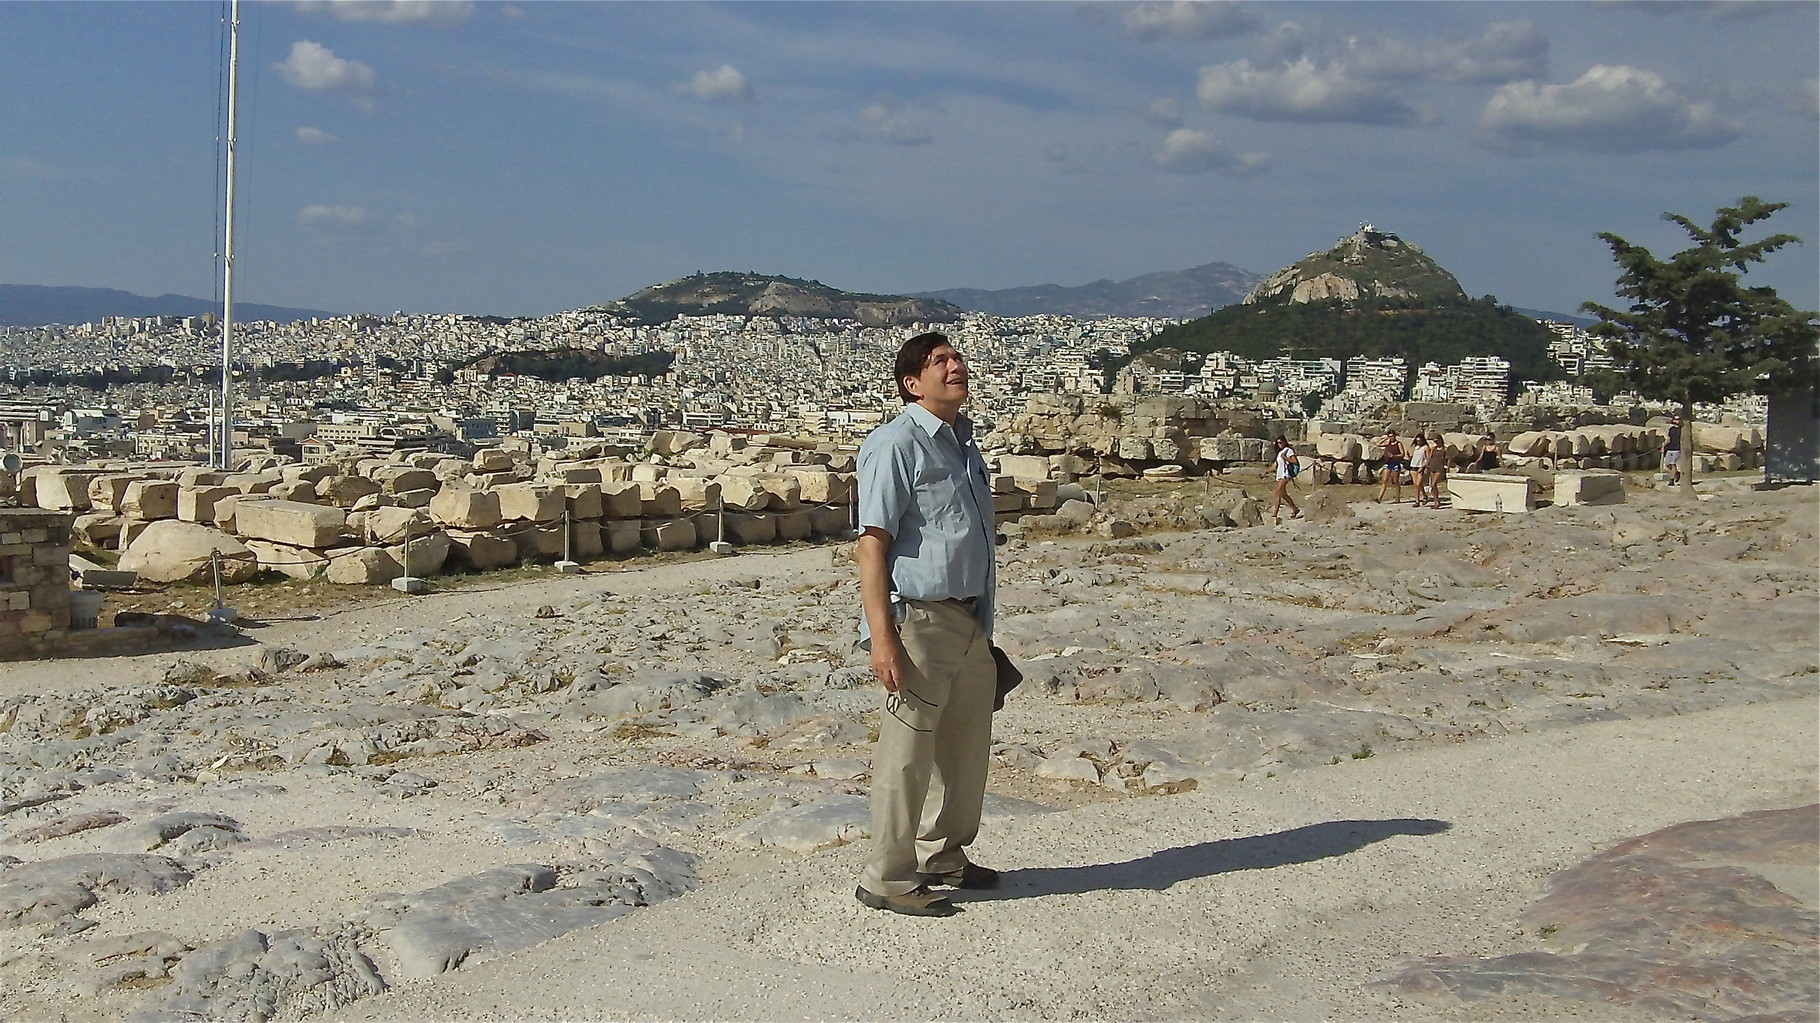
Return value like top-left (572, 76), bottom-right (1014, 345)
top-left (917, 262), bottom-right (1263, 320)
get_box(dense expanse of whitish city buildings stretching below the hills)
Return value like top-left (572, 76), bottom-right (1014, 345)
top-left (0, 302), bottom-right (1753, 461)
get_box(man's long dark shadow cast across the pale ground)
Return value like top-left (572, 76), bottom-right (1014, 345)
top-left (952, 817), bottom-right (1452, 903)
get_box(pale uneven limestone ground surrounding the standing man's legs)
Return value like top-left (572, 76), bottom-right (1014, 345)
top-left (0, 488), bottom-right (1820, 1021)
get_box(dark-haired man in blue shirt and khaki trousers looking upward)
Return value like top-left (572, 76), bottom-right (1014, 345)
top-left (855, 333), bottom-right (999, 916)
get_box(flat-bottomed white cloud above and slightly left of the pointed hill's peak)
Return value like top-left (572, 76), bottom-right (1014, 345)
top-left (1196, 56), bottom-right (1423, 126)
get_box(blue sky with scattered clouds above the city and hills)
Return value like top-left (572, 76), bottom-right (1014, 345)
top-left (0, 0), bottom-right (1820, 315)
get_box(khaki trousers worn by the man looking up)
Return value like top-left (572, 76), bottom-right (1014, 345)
top-left (859, 601), bottom-right (997, 896)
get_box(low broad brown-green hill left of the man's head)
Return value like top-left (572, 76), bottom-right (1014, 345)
top-left (599, 271), bottom-right (961, 328)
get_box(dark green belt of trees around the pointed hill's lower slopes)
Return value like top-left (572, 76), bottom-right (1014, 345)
top-left (1132, 295), bottom-right (1560, 380)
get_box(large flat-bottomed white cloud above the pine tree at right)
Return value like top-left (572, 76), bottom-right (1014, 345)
top-left (1480, 64), bottom-right (1740, 153)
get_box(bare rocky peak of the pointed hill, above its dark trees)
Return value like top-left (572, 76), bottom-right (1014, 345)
top-left (1245, 224), bottom-right (1467, 306)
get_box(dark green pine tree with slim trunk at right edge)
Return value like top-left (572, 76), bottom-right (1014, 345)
top-left (1582, 195), bottom-right (1820, 491)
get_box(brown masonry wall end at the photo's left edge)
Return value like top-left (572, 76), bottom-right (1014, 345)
top-left (0, 508), bottom-right (75, 659)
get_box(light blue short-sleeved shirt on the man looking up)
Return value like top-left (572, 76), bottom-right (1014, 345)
top-left (859, 402), bottom-right (997, 639)
